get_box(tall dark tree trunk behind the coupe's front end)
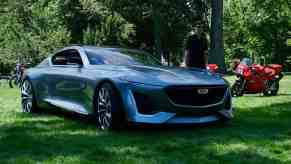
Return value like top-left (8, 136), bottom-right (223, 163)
top-left (209, 0), bottom-right (226, 73)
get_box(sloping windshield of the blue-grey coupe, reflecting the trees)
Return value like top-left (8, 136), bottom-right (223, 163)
top-left (85, 49), bottom-right (161, 65)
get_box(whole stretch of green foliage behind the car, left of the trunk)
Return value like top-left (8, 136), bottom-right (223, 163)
top-left (0, 0), bottom-right (208, 72)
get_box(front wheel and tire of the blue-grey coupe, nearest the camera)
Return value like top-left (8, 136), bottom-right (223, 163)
top-left (94, 82), bottom-right (125, 130)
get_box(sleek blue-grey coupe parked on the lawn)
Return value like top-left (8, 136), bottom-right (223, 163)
top-left (21, 46), bottom-right (233, 129)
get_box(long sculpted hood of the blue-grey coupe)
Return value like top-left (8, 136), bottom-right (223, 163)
top-left (121, 65), bottom-right (226, 86)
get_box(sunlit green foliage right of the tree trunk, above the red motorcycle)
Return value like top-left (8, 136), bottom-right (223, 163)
top-left (224, 0), bottom-right (291, 68)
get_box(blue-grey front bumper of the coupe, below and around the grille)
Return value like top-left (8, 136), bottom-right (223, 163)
top-left (119, 81), bottom-right (233, 124)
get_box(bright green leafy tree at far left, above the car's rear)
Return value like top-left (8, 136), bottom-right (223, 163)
top-left (0, 0), bottom-right (69, 70)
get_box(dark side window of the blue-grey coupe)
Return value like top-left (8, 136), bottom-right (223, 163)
top-left (52, 49), bottom-right (83, 65)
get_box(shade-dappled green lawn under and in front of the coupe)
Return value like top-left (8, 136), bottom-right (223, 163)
top-left (0, 102), bottom-right (291, 163)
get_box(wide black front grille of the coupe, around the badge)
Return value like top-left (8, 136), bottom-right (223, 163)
top-left (165, 85), bottom-right (227, 106)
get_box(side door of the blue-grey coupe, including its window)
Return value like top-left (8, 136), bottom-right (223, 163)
top-left (47, 49), bottom-right (87, 114)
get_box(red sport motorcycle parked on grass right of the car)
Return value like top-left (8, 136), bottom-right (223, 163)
top-left (231, 58), bottom-right (283, 96)
